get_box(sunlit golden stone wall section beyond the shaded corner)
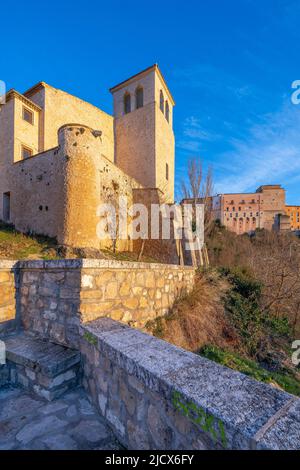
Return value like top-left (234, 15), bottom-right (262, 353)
top-left (80, 260), bottom-right (195, 328)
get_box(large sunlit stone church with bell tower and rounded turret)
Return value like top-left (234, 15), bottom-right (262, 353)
top-left (0, 64), bottom-right (174, 255)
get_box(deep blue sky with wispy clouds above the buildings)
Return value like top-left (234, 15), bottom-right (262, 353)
top-left (0, 0), bottom-right (300, 204)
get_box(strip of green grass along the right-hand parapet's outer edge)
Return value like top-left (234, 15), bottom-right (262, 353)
top-left (199, 345), bottom-right (300, 396)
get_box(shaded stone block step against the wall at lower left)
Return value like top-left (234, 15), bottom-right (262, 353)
top-left (4, 333), bottom-right (81, 401)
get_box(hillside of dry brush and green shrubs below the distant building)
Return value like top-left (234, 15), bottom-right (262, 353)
top-left (147, 224), bottom-right (300, 396)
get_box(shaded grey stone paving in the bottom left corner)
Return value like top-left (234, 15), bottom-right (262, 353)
top-left (0, 388), bottom-right (121, 450)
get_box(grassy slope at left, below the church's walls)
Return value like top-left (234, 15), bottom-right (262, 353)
top-left (0, 222), bottom-right (59, 259)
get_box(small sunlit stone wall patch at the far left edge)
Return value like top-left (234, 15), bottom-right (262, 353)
top-left (0, 260), bottom-right (18, 333)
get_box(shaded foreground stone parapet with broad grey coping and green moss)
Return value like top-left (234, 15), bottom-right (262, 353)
top-left (81, 319), bottom-right (300, 450)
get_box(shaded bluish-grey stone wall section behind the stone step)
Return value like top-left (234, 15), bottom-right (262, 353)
top-left (19, 260), bottom-right (81, 348)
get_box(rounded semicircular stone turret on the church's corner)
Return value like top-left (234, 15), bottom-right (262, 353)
top-left (58, 124), bottom-right (102, 249)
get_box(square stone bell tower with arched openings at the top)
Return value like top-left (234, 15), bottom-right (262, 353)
top-left (110, 64), bottom-right (175, 202)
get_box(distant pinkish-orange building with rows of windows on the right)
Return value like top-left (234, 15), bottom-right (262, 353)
top-left (212, 184), bottom-right (285, 235)
